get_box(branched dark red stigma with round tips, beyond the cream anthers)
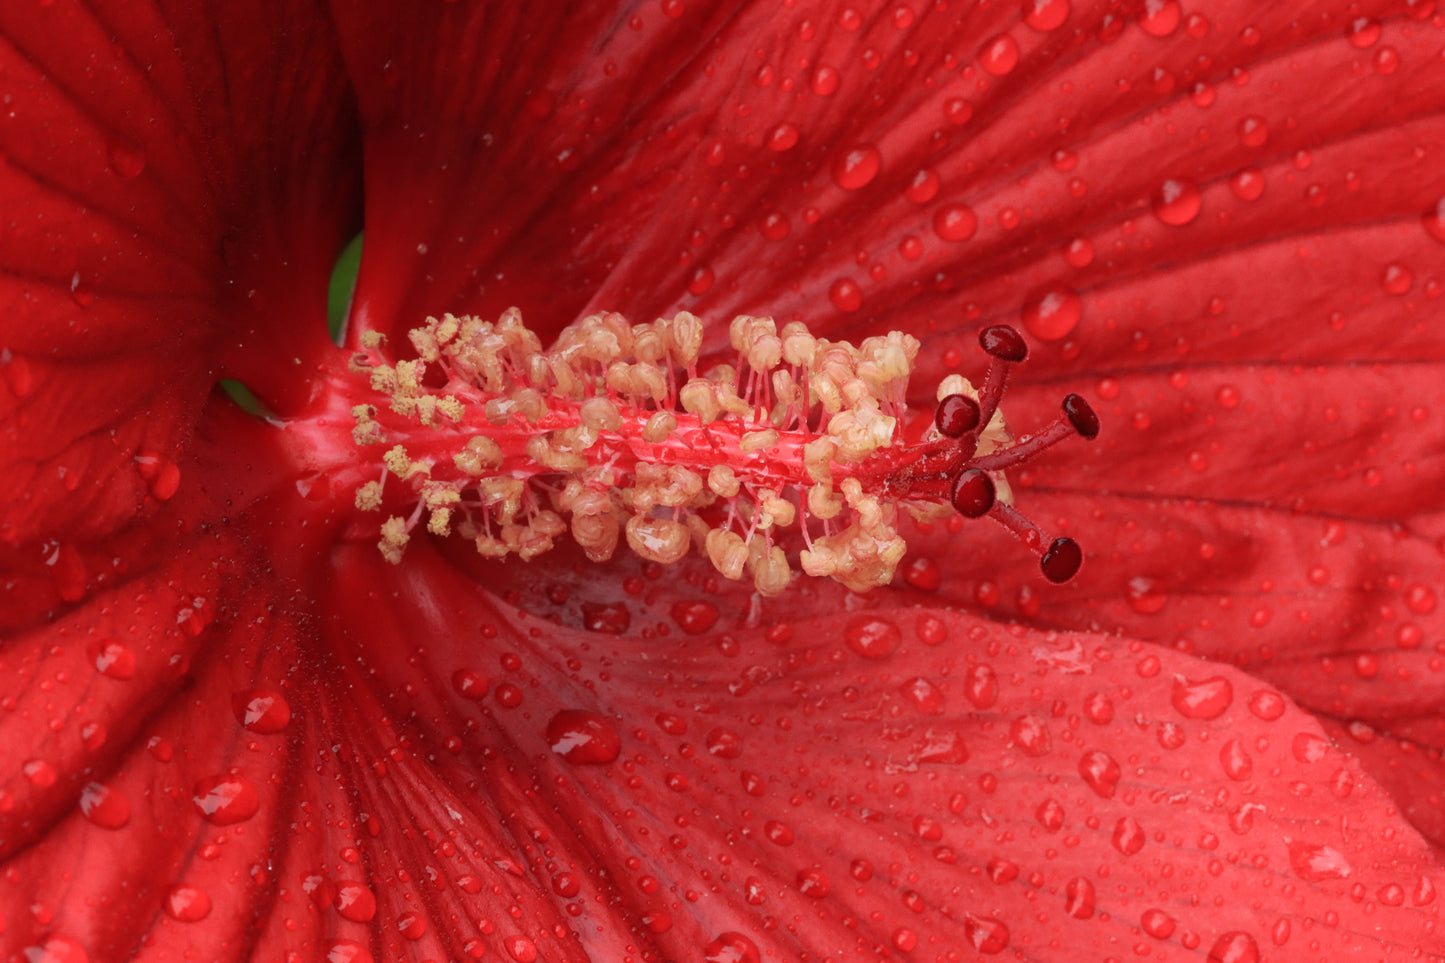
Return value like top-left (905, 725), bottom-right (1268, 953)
top-left (933, 324), bottom-right (1100, 583)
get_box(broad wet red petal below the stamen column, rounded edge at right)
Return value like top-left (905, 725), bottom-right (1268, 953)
top-left (14, 520), bottom-right (1445, 960)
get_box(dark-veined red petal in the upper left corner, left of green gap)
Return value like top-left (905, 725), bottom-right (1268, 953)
top-left (0, 3), bottom-right (354, 544)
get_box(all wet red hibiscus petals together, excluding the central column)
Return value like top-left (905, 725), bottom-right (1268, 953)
top-left (0, 0), bottom-right (1445, 963)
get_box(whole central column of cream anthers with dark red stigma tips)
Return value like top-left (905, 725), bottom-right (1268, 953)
top-left (353, 309), bottom-right (1098, 596)
